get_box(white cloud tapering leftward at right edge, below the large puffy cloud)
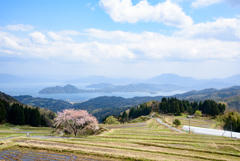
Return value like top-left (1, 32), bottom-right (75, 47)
top-left (175, 18), bottom-right (240, 41)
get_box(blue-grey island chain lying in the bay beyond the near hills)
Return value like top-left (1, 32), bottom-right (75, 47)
top-left (39, 83), bottom-right (187, 94)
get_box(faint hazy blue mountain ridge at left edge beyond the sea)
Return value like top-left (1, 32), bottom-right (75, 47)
top-left (0, 74), bottom-right (56, 83)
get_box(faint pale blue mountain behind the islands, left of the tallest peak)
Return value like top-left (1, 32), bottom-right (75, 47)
top-left (64, 76), bottom-right (142, 84)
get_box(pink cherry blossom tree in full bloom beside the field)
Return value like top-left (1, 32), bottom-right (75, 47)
top-left (54, 109), bottom-right (98, 136)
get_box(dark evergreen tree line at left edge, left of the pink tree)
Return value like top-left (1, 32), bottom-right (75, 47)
top-left (0, 99), bottom-right (55, 127)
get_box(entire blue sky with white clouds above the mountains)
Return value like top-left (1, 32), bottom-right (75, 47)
top-left (0, 0), bottom-right (240, 79)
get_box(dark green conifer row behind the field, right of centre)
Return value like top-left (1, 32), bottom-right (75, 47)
top-left (159, 97), bottom-right (226, 116)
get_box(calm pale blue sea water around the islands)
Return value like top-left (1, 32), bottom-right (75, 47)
top-left (0, 83), bottom-right (186, 102)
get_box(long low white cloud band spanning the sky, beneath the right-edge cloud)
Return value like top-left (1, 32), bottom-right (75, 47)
top-left (0, 29), bottom-right (240, 63)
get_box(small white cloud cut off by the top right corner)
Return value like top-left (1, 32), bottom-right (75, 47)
top-left (191, 0), bottom-right (240, 8)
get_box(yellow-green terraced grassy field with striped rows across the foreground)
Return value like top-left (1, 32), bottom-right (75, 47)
top-left (0, 119), bottom-right (240, 161)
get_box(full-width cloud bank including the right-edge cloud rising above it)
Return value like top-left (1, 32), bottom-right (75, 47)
top-left (0, 18), bottom-right (240, 63)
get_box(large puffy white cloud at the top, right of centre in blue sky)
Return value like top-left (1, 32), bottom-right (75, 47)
top-left (99, 0), bottom-right (193, 27)
